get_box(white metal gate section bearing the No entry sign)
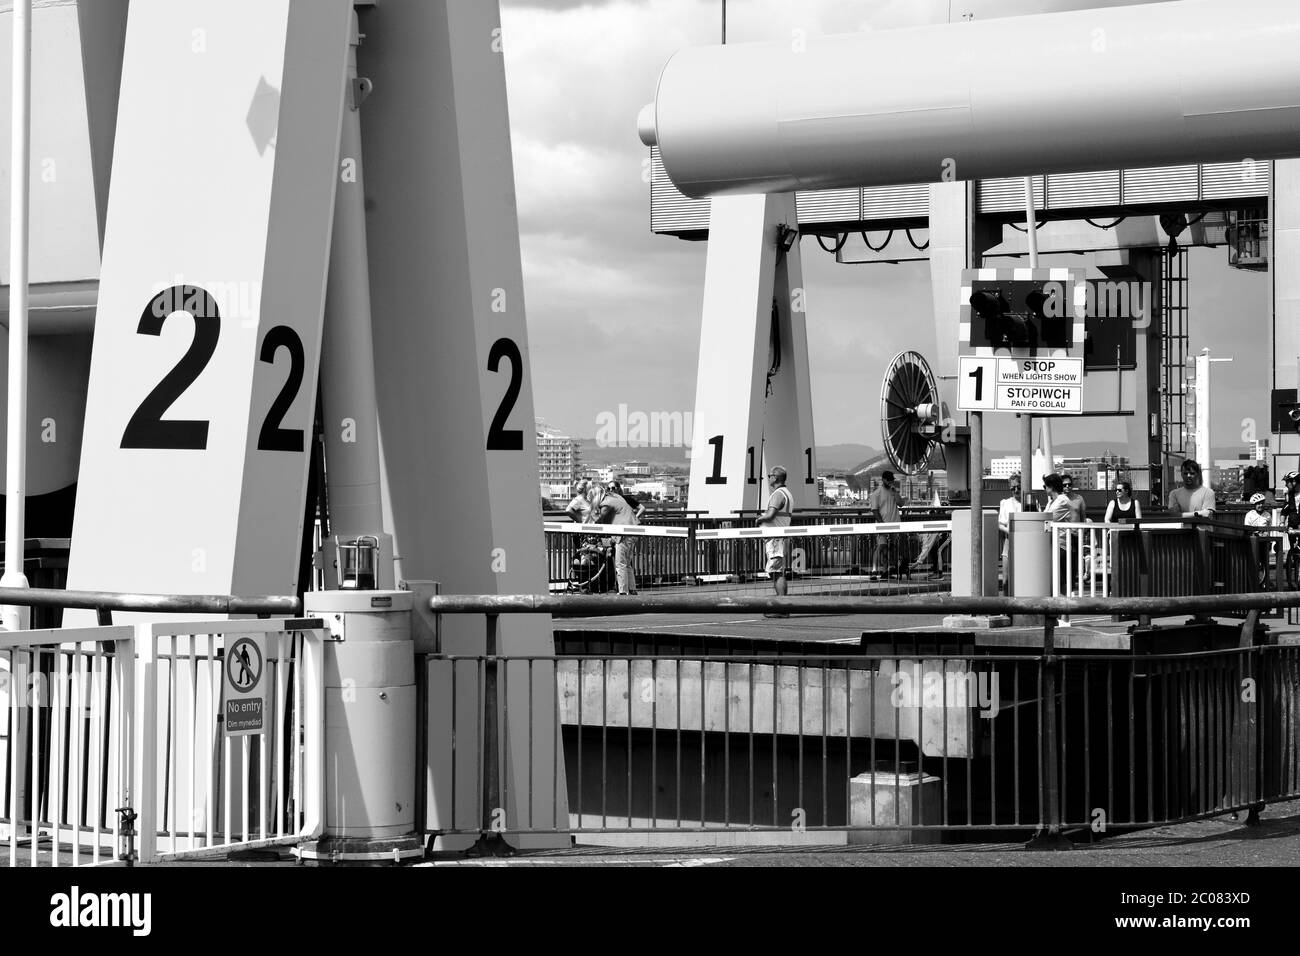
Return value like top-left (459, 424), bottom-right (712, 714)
top-left (137, 619), bottom-right (325, 862)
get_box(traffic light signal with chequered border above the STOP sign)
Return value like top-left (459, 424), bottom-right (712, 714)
top-left (970, 281), bottom-right (1074, 350)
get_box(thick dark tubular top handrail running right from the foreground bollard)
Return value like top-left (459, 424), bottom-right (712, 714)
top-left (429, 591), bottom-right (1300, 617)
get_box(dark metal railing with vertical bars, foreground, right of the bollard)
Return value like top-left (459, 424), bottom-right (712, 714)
top-left (425, 593), bottom-right (1300, 842)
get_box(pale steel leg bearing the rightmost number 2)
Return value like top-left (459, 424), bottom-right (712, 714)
top-left (358, 0), bottom-right (564, 848)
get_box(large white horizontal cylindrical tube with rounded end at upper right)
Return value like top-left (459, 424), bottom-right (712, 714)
top-left (637, 0), bottom-right (1300, 198)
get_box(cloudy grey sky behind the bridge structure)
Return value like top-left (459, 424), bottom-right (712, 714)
top-left (502, 0), bottom-right (1270, 457)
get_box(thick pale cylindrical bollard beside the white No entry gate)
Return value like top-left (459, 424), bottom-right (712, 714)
top-left (298, 591), bottom-right (424, 865)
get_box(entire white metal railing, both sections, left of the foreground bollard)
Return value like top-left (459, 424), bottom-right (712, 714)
top-left (0, 613), bottom-right (325, 866)
